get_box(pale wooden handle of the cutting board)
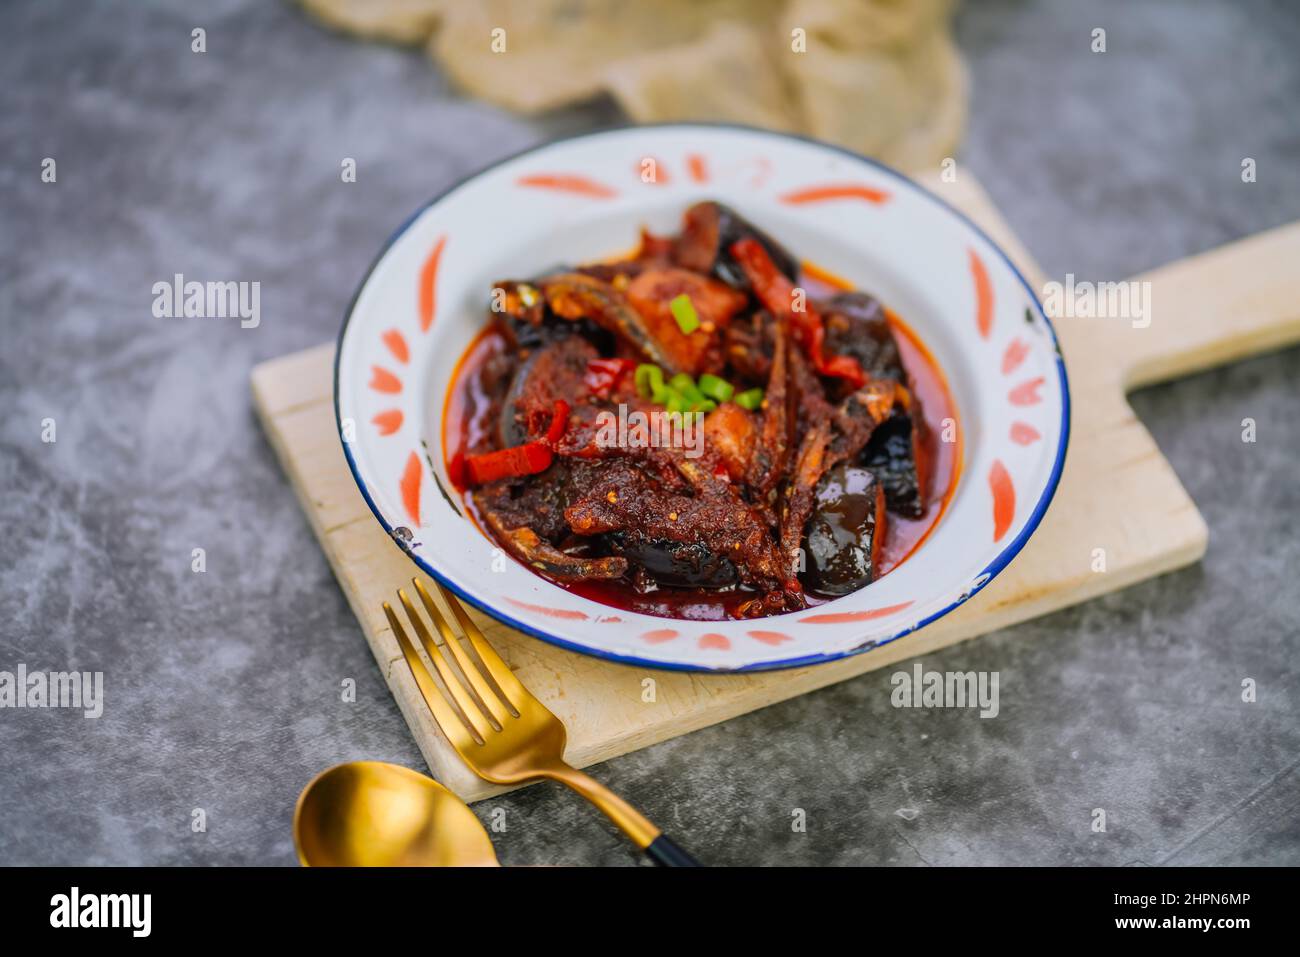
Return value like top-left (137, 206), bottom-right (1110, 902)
top-left (1107, 222), bottom-right (1300, 390)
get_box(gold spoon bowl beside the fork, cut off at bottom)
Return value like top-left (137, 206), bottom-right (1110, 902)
top-left (294, 761), bottom-right (499, 867)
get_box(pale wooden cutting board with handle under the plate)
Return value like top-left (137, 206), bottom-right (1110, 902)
top-left (252, 170), bottom-right (1300, 801)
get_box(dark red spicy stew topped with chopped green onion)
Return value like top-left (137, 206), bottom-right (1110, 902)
top-left (443, 203), bottom-right (961, 619)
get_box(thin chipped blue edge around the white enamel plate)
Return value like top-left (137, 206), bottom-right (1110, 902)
top-left (333, 121), bottom-right (1070, 675)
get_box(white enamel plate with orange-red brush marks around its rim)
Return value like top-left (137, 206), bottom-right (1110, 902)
top-left (334, 125), bottom-right (1070, 671)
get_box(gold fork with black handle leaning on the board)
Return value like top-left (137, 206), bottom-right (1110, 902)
top-left (384, 579), bottom-right (699, 867)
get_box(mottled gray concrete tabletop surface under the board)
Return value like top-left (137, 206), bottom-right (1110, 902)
top-left (0, 0), bottom-right (1300, 865)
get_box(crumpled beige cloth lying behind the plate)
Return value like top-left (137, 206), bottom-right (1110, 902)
top-left (298, 0), bottom-right (966, 169)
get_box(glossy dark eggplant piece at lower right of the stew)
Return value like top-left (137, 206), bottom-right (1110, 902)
top-left (805, 464), bottom-right (887, 596)
